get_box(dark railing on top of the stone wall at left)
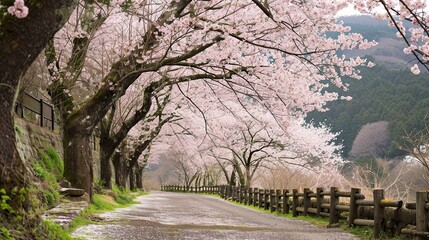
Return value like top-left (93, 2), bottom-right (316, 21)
top-left (15, 92), bottom-right (55, 130)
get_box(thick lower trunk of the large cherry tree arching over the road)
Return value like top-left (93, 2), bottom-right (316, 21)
top-left (63, 126), bottom-right (93, 201)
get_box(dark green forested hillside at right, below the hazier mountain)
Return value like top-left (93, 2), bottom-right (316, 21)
top-left (307, 64), bottom-right (429, 157)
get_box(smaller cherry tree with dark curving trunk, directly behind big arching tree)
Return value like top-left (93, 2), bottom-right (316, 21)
top-left (100, 75), bottom-right (172, 188)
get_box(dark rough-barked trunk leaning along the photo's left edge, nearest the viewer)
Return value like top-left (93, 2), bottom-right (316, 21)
top-left (0, 0), bottom-right (77, 214)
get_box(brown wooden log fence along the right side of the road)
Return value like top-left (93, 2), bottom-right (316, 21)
top-left (161, 185), bottom-right (429, 239)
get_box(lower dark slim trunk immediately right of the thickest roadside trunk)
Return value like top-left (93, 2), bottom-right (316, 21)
top-left (100, 136), bottom-right (115, 189)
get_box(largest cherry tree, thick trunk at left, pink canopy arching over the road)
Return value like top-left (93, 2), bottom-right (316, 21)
top-left (39, 0), bottom-right (374, 199)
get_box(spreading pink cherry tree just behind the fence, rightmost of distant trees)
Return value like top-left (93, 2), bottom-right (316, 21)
top-left (206, 106), bottom-right (342, 187)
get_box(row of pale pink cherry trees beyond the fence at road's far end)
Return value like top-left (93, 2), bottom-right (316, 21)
top-left (153, 98), bottom-right (343, 187)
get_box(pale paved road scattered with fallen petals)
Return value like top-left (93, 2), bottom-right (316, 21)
top-left (73, 192), bottom-right (358, 240)
